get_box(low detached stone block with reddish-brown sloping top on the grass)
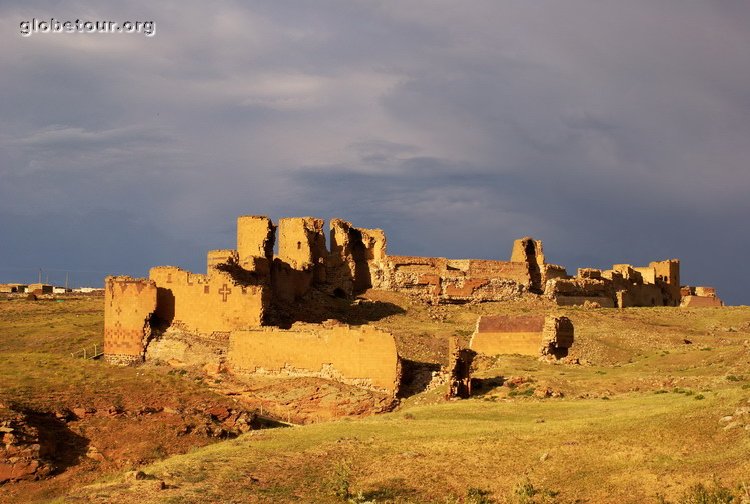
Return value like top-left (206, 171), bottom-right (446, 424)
top-left (469, 315), bottom-right (573, 358)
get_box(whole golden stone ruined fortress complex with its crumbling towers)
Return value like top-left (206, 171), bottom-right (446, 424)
top-left (104, 216), bottom-right (720, 396)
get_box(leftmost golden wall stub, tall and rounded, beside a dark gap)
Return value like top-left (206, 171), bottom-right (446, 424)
top-left (104, 276), bottom-right (156, 364)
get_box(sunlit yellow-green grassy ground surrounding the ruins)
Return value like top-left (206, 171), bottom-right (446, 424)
top-left (0, 294), bottom-right (750, 503)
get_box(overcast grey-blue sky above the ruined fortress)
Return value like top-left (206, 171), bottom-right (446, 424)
top-left (0, 0), bottom-right (750, 304)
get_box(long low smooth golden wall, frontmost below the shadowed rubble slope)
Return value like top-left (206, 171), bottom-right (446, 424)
top-left (228, 323), bottom-right (401, 395)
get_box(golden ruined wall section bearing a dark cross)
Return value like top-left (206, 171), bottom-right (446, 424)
top-left (149, 266), bottom-right (270, 334)
